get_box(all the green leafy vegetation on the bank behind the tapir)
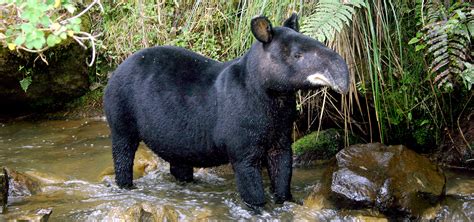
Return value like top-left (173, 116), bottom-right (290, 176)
top-left (0, 0), bottom-right (474, 160)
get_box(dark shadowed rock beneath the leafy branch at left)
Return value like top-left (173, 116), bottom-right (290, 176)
top-left (0, 41), bottom-right (90, 116)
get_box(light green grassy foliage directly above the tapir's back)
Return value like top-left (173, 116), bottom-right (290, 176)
top-left (99, 0), bottom-right (303, 66)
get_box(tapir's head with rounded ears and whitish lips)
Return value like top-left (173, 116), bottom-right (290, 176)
top-left (249, 14), bottom-right (349, 93)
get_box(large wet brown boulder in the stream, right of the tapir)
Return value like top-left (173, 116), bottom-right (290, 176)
top-left (310, 143), bottom-right (446, 217)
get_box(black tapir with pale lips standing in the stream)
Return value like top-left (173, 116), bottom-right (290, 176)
top-left (104, 14), bottom-right (349, 207)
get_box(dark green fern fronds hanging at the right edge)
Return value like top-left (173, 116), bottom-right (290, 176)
top-left (409, 1), bottom-right (474, 91)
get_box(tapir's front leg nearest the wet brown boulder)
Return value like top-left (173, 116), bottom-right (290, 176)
top-left (267, 138), bottom-right (293, 203)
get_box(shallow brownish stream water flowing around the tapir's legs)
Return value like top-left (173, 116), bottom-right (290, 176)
top-left (0, 118), bottom-right (474, 221)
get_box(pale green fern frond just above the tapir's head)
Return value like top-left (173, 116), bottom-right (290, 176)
top-left (301, 0), bottom-right (366, 42)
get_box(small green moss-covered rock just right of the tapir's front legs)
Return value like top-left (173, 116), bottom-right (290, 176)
top-left (291, 128), bottom-right (360, 166)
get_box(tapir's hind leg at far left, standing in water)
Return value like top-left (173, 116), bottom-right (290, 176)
top-left (112, 133), bottom-right (139, 189)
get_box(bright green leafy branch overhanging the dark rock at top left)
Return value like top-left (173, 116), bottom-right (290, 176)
top-left (0, 0), bottom-right (100, 92)
